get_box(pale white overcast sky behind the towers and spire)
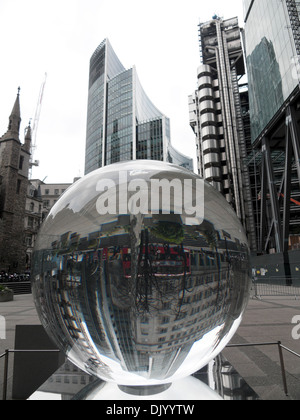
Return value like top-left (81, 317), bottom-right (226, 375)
top-left (0, 0), bottom-right (243, 183)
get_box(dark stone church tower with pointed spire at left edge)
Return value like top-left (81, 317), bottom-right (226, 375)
top-left (0, 89), bottom-right (31, 273)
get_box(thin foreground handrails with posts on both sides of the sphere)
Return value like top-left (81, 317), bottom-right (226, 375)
top-left (0, 341), bottom-right (300, 401)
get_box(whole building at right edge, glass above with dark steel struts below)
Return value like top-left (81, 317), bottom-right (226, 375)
top-left (244, 0), bottom-right (300, 277)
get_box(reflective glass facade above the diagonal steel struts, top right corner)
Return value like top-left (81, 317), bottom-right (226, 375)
top-left (244, 0), bottom-right (300, 142)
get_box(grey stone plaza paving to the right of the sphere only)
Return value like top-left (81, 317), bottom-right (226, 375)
top-left (223, 297), bottom-right (300, 400)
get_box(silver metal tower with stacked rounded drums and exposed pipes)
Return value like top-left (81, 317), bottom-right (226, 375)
top-left (189, 17), bottom-right (256, 250)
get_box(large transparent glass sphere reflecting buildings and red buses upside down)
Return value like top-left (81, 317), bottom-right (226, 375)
top-left (32, 161), bottom-right (250, 386)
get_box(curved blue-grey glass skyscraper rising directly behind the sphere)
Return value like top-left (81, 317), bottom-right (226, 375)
top-left (85, 39), bottom-right (193, 174)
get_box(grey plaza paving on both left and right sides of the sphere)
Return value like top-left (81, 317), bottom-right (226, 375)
top-left (0, 295), bottom-right (300, 400)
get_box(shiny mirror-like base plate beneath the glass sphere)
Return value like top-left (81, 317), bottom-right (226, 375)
top-left (29, 355), bottom-right (259, 405)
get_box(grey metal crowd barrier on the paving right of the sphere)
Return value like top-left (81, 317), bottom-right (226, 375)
top-left (251, 277), bottom-right (300, 299)
